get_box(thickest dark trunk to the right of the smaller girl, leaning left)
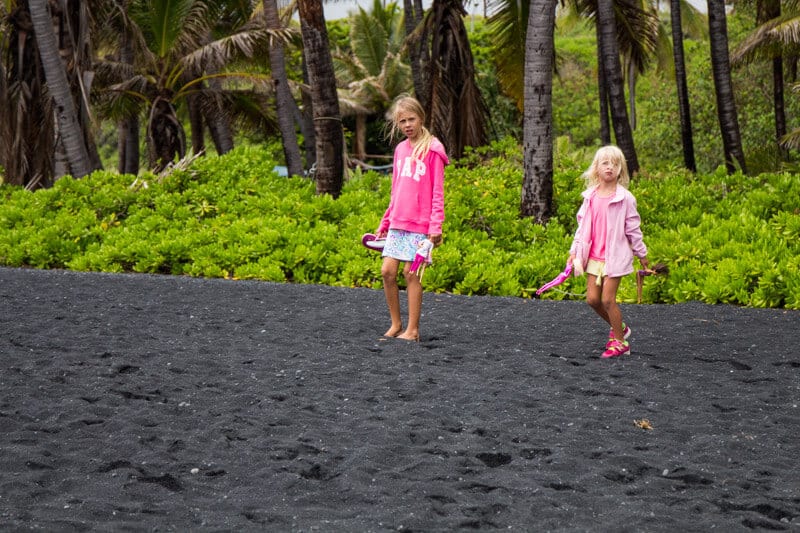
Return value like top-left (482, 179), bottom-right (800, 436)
top-left (708, 0), bottom-right (747, 174)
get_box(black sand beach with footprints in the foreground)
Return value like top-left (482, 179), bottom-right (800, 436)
top-left (0, 269), bottom-right (800, 532)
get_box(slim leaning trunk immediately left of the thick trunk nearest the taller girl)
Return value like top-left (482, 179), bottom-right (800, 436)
top-left (263, 0), bottom-right (303, 176)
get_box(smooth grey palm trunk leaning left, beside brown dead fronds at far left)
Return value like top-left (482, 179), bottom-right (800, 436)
top-left (28, 0), bottom-right (95, 178)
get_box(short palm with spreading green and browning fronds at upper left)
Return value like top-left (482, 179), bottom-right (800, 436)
top-left (96, 0), bottom-right (289, 172)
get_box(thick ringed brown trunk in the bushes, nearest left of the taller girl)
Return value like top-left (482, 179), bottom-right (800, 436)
top-left (298, 0), bottom-right (345, 198)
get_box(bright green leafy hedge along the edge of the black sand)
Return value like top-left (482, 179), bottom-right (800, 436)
top-left (0, 141), bottom-right (800, 309)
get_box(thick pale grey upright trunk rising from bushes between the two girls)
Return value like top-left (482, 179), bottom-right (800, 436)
top-left (520, 0), bottom-right (556, 224)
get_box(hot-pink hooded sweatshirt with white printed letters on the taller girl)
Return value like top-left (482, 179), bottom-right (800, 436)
top-left (378, 138), bottom-right (450, 235)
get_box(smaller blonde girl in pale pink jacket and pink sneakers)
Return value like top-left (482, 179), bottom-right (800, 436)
top-left (568, 146), bottom-right (648, 358)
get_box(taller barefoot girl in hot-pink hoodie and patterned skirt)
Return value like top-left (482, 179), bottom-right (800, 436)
top-left (375, 95), bottom-right (449, 341)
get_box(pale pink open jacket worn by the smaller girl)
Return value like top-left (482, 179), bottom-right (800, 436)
top-left (569, 185), bottom-right (647, 278)
